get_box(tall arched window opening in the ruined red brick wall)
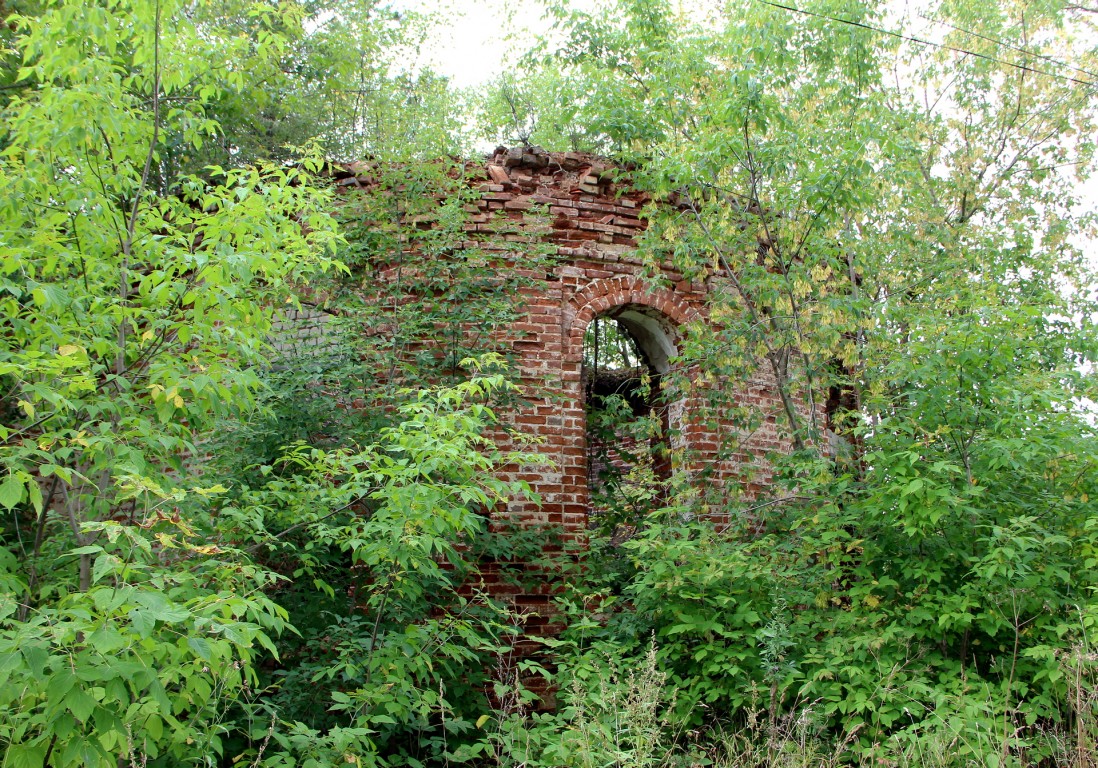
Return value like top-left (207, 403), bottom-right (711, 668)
top-left (582, 307), bottom-right (675, 543)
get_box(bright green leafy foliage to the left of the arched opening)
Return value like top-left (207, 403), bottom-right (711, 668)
top-left (0, 2), bottom-right (535, 766)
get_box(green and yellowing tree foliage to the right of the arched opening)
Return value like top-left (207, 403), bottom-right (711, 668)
top-left (487, 2), bottom-right (1098, 764)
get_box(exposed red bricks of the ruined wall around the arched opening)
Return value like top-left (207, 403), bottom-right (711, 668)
top-left (329, 151), bottom-right (821, 646)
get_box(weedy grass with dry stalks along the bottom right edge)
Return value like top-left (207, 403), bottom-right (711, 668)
top-left (493, 647), bottom-right (1098, 768)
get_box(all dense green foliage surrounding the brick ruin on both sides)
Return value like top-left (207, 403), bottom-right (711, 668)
top-left (0, 0), bottom-right (1098, 767)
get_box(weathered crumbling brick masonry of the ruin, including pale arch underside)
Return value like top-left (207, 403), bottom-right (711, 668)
top-left (337, 148), bottom-right (812, 619)
